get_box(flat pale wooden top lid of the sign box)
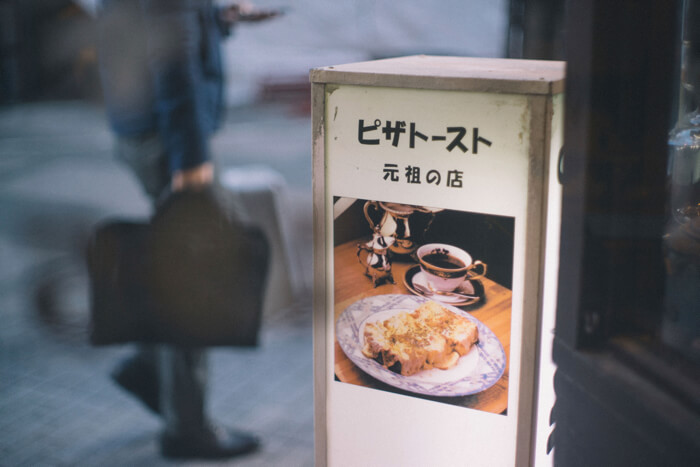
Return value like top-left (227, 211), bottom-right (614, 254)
top-left (309, 55), bottom-right (565, 95)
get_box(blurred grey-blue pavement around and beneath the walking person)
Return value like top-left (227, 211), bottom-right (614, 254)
top-left (0, 102), bottom-right (313, 466)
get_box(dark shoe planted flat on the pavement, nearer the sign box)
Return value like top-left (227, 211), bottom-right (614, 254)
top-left (160, 427), bottom-right (260, 459)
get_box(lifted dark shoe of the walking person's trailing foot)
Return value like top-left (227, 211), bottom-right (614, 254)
top-left (112, 354), bottom-right (160, 414)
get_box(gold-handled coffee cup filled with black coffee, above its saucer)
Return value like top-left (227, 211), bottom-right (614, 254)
top-left (416, 243), bottom-right (486, 292)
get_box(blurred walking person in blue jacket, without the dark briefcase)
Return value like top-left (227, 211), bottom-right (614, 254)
top-left (98, 0), bottom-right (278, 458)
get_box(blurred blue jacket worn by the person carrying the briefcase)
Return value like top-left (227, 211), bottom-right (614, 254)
top-left (98, 0), bottom-right (230, 172)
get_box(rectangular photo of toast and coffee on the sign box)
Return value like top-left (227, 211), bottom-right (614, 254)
top-left (333, 197), bottom-right (515, 414)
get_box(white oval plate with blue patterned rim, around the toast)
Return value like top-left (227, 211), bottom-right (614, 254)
top-left (335, 294), bottom-right (506, 397)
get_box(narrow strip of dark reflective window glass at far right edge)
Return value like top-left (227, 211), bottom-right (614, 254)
top-left (661, 0), bottom-right (700, 362)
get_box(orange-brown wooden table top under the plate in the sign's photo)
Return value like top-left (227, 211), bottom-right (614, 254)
top-left (334, 239), bottom-right (512, 413)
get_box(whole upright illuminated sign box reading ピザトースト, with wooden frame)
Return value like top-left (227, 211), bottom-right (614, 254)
top-left (311, 56), bottom-right (564, 466)
